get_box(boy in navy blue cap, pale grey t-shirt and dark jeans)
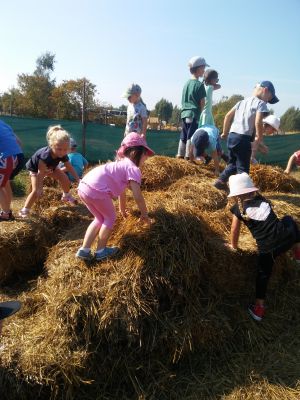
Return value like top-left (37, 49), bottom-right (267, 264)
top-left (214, 81), bottom-right (279, 191)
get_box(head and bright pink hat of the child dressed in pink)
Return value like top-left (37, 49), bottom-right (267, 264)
top-left (117, 132), bottom-right (154, 167)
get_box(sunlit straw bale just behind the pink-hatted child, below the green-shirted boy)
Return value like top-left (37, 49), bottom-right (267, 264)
top-left (142, 156), bottom-right (213, 190)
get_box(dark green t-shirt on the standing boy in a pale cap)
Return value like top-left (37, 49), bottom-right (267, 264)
top-left (181, 79), bottom-right (206, 121)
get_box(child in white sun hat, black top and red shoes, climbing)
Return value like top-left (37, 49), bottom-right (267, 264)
top-left (228, 172), bottom-right (300, 321)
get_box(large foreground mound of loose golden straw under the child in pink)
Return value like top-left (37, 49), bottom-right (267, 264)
top-left (0, 157), bottom-right (300, 400)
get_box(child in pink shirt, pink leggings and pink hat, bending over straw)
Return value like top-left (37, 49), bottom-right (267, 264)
top-left (76, 132), bottom-right (154, 261)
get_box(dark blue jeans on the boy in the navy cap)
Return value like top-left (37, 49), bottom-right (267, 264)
top-left (220, 132), bottom-right (251, 182)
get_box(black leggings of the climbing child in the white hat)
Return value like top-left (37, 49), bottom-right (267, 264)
top-left (256, 215), bottom-right (300, 299)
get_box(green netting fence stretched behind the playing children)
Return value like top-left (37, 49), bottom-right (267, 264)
top-left (0, 116), bottom-right (300, 167)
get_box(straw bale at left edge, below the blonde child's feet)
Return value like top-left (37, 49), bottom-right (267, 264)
top-left (0, 219), bottom-right (55, 283)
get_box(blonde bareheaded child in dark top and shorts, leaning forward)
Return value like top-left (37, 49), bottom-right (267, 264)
top-left (19, 125), bottom-right (79, 218)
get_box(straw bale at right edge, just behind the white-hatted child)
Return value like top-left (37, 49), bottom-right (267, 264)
top-left (250, 164), bottom-right (300, 193)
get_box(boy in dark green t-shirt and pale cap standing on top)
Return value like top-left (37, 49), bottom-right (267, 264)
top-left (177, 56), bottom-right (209, 160)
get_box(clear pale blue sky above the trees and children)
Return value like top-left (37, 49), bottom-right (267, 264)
top-left (0, 0), bottom-right (300, 116)
